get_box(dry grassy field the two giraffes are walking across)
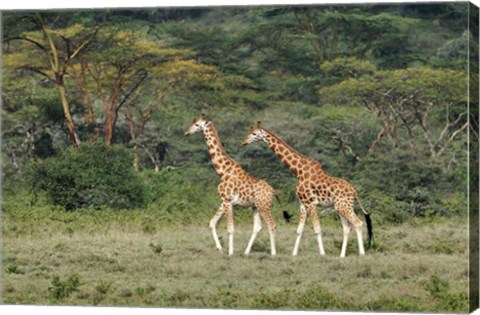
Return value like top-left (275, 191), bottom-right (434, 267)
top-left (2, 201), bottom-right (468, 313)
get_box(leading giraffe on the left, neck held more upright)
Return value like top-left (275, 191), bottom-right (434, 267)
top-left (185, 114), bottom-right (276, 256)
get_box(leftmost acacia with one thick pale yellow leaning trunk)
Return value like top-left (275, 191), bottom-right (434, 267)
top-left (3, 13), bottom-right (98, 146)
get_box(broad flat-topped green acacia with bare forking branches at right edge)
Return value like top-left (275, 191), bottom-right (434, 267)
top-left (320, 68), bottom-right (468, 159)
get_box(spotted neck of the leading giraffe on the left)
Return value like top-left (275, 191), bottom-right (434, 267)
top-left (203, 122), bottom-right (237, 177)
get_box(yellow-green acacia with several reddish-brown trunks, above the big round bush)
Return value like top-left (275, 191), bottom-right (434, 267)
top-left (70, 28), bottom-right (193, 145)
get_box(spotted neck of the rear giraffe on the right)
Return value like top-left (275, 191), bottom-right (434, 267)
top-left (263, 129), bottom-right (320, 177)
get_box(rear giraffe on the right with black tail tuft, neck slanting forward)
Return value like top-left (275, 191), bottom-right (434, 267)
top-left (242, 121), bottom-right (373, 257)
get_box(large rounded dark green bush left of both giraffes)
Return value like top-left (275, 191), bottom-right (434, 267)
top-left (30, 144), bottom-right (147, 210)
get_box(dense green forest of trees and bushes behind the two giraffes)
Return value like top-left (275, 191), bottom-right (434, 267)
top-left (2, 3), bottom-right (478, 223)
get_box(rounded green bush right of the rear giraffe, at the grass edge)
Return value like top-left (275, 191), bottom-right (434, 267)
top-left (353, 149), bottom-right (466, 224)
